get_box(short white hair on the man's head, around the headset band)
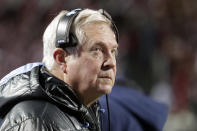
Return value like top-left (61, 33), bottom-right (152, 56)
top-left (42, 9), bottom-right (111, 70)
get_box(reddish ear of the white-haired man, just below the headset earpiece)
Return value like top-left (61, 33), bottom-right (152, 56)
top-left (53, 48), bottom-right (68, 73)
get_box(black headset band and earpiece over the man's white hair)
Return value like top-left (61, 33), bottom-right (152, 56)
top-left (56, 8), bottom-right (119, 48)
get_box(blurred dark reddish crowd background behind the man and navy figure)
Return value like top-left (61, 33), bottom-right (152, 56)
top-left (0, 0), bottom-right (197, 131)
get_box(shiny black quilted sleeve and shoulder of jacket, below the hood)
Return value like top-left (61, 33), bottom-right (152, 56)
top-left (0, 100), bottom-right (83, 131)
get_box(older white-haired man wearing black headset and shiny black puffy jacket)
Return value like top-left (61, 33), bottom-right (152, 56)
top-left (0, 9), bottom-right (118, 131)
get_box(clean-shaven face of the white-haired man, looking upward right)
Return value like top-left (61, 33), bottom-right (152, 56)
top-left (67, 23), bottom-right (118, 102)
